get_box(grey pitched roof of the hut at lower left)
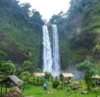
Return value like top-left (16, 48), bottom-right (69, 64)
top-left (0, 75), bottom-right (23, 85)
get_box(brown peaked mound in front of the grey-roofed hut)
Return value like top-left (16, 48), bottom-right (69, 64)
top-left (5, 87), bottom-right (23, 97)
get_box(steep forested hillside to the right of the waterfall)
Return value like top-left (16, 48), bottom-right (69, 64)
top-left (50, 0), bottom-right (100, 73)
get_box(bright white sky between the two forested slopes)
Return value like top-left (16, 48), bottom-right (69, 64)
top-left (19, 0), bottom-right (71, 20)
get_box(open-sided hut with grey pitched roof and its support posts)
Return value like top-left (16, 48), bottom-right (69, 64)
top-left (0, 75), bottom-right (23, 95)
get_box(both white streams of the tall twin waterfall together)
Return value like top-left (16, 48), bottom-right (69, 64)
top-left (42, 25), bottom-right (61, 77)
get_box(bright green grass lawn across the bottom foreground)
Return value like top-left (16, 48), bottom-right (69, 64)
top-left (24, 84), bottom-right (100, 97)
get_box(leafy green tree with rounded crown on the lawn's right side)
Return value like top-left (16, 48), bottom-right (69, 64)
top-left (77, 61), bottom-right (96, 89)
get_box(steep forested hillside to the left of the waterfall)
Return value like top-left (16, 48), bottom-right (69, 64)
top-left (0, 0), bottom-right (43, 65)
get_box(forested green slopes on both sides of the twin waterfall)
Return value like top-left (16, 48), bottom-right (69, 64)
top-left (0, 0), bottom-right (100, 73)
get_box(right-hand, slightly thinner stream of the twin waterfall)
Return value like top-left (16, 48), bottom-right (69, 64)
top-left (52, 25), bottom-right (60, 76)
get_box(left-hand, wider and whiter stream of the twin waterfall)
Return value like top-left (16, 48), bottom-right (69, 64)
top-left (42, 26), bottom-right (52, 73)
